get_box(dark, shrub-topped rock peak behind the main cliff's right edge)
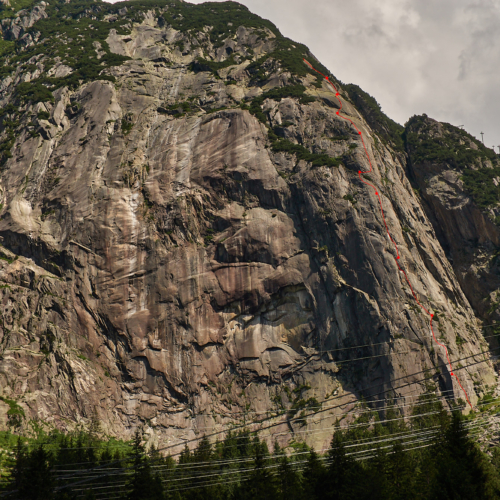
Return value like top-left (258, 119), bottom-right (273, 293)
top-left (406, 117), bottom-right (500, 346)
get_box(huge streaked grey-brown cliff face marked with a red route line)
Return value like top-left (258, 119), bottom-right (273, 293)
top-left (0, 1), bottom-right (497, 446)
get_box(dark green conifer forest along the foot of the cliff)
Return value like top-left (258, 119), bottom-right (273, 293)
top-left (1, 397), bottom-right (500, 500)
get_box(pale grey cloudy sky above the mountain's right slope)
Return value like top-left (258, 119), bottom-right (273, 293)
top-left (108, 0), bottom-right (500, 148)
